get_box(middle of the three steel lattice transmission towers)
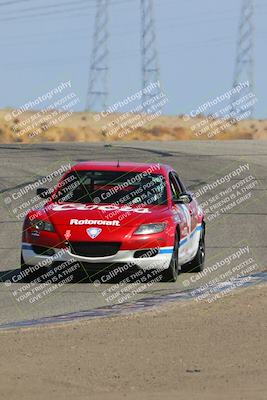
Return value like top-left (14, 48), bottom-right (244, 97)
top-left (141, 0), bottom-right (160, 112)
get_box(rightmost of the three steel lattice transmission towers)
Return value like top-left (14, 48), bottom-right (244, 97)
top-left (232, 0), bottom-right (254, 114)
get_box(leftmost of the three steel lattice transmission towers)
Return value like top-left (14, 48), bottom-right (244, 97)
top-left (86, 0), bottom-right (109, 111)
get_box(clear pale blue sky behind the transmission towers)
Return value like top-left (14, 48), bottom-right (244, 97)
top-left (0, 0), bottom-right (267, 118)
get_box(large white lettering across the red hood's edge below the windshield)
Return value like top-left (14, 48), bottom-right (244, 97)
top-left (52, 203), bottom-right (151, 214)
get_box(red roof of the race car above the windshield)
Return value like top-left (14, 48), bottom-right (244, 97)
top-left (71, 161), bottom-right (173, 174)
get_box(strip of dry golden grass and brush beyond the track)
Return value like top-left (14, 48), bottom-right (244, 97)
top-left (0, 110), bottom-right (267, 143)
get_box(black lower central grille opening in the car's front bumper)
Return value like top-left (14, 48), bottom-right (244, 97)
top-left (70, 242), bottom-right (121, 257)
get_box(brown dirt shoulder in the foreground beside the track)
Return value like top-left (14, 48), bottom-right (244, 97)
top-left (0, 285), bottom-right (267, 400)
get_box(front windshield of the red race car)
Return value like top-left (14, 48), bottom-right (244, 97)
top-left (53, 171), bottom-right (167, 205)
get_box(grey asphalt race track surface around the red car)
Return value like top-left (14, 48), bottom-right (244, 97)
top-left (0, 141), bottom-right (267, 324)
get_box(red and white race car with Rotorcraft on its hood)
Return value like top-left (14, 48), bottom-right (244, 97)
top-left (21, 162), bottom-right (205, 282)
